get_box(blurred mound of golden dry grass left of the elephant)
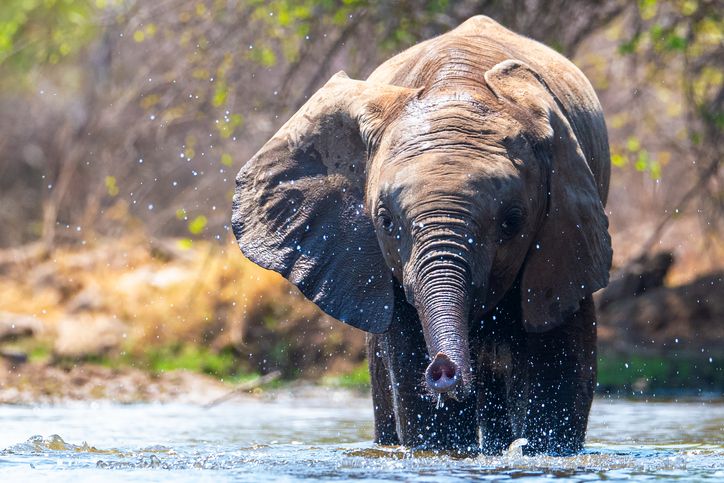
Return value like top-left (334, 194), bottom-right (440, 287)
top-left (0, 236), bottom-right (364, 378)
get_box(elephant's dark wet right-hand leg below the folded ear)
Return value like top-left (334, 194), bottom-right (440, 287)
top-left (524, 297), bottom-right (596, 455)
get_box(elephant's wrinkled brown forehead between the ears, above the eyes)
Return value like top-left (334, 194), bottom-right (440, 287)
top-left (375, 87), bottom-right (536, 214)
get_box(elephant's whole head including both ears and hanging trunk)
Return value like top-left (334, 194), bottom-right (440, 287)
top-left (232, 61), bottom-right (611, 397)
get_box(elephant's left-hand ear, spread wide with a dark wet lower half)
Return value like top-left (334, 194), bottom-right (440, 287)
top-left (231, 72), bottom-right (411, 333)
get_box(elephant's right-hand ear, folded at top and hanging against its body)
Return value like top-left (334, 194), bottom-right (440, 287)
top-left (485, 60), bottom-right (612, 332)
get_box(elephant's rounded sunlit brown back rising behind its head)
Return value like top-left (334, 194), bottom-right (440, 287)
top-left (368, 15), bottom-right (611, 205)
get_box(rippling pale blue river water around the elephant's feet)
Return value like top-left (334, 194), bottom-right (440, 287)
top-left (0, 389), bottom-right (724, 482)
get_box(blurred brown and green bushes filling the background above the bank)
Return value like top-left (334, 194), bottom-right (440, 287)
top-left (0, 0), bottom-right (724, 390)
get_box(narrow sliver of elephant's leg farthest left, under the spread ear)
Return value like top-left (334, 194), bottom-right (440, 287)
top-left (367, 334), bottom-right (400, 445)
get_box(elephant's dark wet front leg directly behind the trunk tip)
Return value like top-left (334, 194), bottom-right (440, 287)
top-left (381, 286), bottom-right (479, 452)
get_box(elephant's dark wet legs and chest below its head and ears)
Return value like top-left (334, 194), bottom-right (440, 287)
top-left (367, 285), bottom-right (596, 455)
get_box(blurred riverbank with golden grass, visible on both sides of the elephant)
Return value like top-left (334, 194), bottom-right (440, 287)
top-left (0, 236), bottom-right (724, 404)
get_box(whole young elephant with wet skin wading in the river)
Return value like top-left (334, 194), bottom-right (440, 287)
top-left (232, 16), bottom-right (612, 455)
